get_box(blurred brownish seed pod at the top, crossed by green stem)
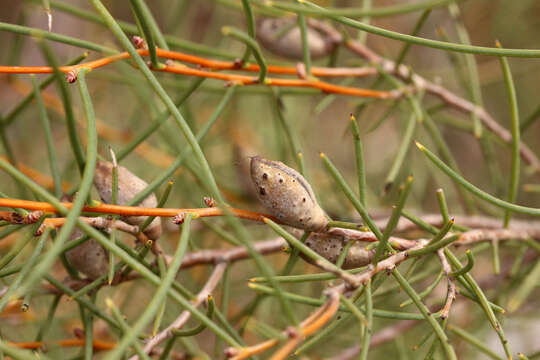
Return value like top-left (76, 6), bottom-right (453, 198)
top-left (256, 17), bottom-right (337, 60)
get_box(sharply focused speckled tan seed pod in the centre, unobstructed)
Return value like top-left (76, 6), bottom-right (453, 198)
top-left (251, 156), bottom-right (328, 231)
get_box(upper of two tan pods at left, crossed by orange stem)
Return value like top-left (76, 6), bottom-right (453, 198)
top-left (94, 161), bottom-right (161, 240)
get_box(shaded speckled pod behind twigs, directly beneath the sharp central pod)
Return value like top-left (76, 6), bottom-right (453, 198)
top-left (298, 233), bottom-right (373, 269)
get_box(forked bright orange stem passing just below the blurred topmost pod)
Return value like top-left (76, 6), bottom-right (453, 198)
top-left (0, 48), bottom-right (392, 99)
